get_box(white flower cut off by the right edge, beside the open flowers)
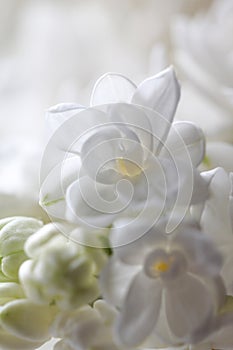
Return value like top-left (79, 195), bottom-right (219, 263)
top-left (193, 168), bottom-right (233, 295)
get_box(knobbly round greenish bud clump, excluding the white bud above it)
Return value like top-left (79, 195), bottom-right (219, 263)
top-left (19, 242), bottom-right (99, 309)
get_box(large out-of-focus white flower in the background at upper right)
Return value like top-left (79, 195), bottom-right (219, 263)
top-left (172, 0), bottom-right (233, 142)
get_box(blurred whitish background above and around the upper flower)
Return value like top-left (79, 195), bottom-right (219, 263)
top-left (0, 0), bottom-right (233, 218)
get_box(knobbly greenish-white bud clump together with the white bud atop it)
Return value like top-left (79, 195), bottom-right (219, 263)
top-left (19, 224), bottom-right (105, 309)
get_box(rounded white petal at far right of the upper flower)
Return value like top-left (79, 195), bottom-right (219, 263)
top-left (161, 122), bottom-right (205, 167)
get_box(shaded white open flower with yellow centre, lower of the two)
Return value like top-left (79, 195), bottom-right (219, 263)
top-left (100, 221), bottom-right (225, 347)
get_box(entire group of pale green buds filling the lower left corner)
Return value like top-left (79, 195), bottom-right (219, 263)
top-left (0, 217), bottom-right (107, 350)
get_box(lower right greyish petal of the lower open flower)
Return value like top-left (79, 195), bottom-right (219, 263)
top-left (165, 274), bottom-right (214, 338)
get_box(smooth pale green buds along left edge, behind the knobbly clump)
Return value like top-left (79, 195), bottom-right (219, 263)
top-left (0, 217), bottom-right (54, 350)
